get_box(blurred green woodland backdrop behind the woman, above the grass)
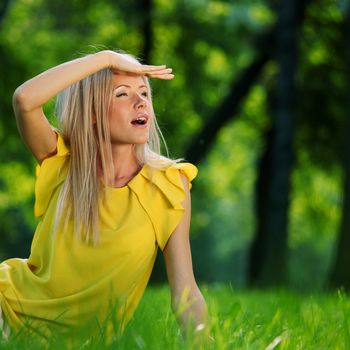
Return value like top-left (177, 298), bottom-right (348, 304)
top-left (0, 0), bottom-right (350, 290)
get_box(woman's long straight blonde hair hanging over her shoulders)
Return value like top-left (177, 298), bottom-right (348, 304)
top-left (54, 54), bottom-right (179, 244)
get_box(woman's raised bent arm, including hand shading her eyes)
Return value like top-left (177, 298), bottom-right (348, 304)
top-left (13, 50), bottom-right (172, 163)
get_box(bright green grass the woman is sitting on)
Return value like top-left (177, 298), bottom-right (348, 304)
top-left (1, 285), bottom-right (350, 350)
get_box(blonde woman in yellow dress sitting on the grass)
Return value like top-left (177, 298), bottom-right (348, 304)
top-left (0, 50), bottom-right (207, 344)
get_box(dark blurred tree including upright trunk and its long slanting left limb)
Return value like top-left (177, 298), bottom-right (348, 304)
top-left (180, 2), bottom-right (303, 283)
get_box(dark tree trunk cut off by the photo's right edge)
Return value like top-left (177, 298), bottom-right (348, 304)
top-left (329, 2), bottom-right (350, 290)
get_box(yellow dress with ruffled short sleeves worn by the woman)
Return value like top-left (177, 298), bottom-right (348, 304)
top-left (0, 136), bottom-right (197, 337)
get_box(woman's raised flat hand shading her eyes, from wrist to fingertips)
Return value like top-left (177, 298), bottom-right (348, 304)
top-left (106, 50), bottom-right (174, 80)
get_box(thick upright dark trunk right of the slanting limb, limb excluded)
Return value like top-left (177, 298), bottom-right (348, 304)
top-left (249, 0), bottom-right (298, 286)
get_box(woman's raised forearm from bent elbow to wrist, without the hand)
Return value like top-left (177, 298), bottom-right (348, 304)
top-left (14, 51), bottom-right (109, 111)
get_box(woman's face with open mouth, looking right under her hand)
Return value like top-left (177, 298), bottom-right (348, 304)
top-left (108, 74), bottom-right (153, 144)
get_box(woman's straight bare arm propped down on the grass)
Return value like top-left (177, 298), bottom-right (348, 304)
top-left (163, 175), bottom-right (208, 334)
